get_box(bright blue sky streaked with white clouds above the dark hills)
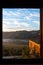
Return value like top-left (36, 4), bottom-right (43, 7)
top-left (2, 8), bottom-right (40, 32)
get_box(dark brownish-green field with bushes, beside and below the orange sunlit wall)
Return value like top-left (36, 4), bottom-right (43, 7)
top-left (2, 42), bottom-right (40, 59)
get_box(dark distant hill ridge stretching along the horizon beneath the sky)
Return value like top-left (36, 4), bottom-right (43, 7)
top-left (3, 30), bottom-right (40, 42)
